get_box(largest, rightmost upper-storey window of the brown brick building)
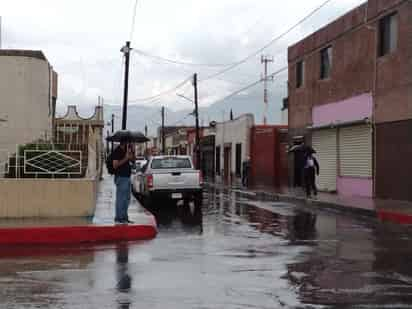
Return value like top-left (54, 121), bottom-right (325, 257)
top-left (379, 14), bottom-right (398, 57)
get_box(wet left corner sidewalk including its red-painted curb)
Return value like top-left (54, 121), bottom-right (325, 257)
top-left (0, 175), bottom-right (157, 246)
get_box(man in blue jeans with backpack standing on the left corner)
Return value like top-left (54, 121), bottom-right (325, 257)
top-left (112, 139), bottom-right (135, 223)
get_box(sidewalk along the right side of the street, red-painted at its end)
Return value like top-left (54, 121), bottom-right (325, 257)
top-left (208, 183), bottom-right (412, 224)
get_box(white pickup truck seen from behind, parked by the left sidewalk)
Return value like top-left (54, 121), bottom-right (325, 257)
top-left (133, 156), bottom-right (203, 208)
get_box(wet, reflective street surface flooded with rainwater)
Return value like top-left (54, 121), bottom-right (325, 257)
top-left (0, 188), bottom-right (412, 309)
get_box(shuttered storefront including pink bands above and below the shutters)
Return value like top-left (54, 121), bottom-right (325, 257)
top-left (310, 93), bottom-right (373, 197)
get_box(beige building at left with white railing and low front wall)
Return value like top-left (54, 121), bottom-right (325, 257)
top-left (0, 50), bottom-right (104, 218)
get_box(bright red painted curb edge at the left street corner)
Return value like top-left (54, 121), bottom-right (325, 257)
top-left (0, 224), bottom-right (157, 245)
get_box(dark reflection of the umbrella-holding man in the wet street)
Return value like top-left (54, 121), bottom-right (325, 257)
top-left (116, 242), bottom-right (133, 309)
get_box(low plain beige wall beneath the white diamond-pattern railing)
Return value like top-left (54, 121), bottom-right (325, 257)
top-left (0, 179), bottom-right (98, 218)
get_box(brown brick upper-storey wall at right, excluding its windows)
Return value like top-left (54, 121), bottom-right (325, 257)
top-left (288, 0), bottom-right (412, 132)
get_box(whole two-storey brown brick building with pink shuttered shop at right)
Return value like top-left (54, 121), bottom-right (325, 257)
top-left (288, 0), bottom-right (412, 200)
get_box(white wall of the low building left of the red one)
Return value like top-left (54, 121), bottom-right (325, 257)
top-left (215, 114), bottom-right (255, 177)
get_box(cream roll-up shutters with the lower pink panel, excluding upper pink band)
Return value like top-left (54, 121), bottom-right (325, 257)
top-left (312, 121), bottom-right (373, 197)
